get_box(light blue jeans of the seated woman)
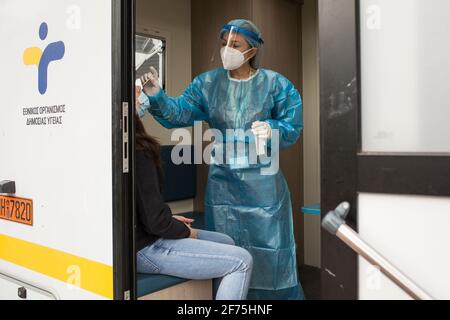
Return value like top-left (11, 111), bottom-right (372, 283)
top-left (137, 230), bottom-right (253, 300)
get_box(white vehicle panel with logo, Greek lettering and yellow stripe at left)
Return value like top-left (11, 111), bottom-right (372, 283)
top-left (0, 0), bottom-right (134, 299)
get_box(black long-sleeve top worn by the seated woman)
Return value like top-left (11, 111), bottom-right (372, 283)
top-left (136, 151), bottom-right (190, 251)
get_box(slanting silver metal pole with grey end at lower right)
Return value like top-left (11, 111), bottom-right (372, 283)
top-left (322, 202), bottom-right (434, 300)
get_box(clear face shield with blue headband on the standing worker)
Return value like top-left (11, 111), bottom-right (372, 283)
top-left (213, 25), bottom-right (264, 70)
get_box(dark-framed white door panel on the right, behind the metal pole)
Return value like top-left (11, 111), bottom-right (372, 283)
top-left (319, 0), bottom-right (450, 299)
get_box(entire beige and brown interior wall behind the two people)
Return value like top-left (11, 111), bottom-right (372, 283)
top-left (136, 0), bottom-right (320, 266)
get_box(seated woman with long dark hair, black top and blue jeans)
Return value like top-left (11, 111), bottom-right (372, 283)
top-left (136, 112), bottom-right (253, 300)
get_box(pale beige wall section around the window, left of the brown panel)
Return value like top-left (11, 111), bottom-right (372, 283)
top-left (136, 0), bottom-right (194, 214)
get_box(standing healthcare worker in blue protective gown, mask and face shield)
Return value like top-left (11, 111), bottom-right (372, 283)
top-left (141, 20), bottom-right (304, 300)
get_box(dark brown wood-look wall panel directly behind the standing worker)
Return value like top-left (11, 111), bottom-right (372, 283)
top-left (191, 0), bottom-right (304, 264)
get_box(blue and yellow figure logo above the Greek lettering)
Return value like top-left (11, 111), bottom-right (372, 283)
top-left (23, 22), bottom-right (66, 95)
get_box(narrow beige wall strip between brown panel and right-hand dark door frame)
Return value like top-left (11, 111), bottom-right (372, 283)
top-left (302, 0), bottom-right (321, 268)
